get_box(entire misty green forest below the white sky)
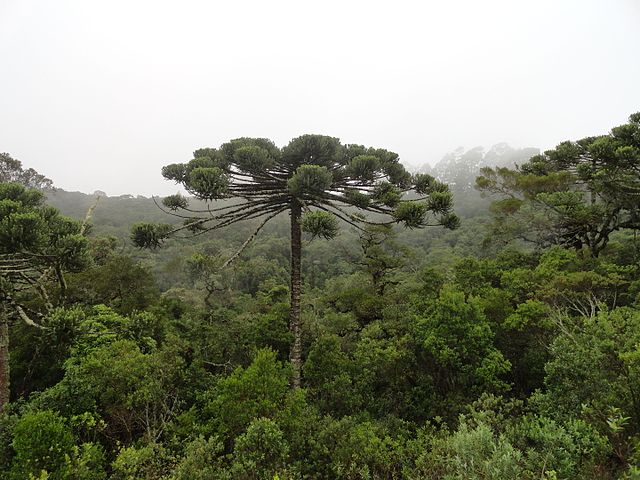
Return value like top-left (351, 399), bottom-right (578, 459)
top-left (0, 114), bottom-right (640, 480)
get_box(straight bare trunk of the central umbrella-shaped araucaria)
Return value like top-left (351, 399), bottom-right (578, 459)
top-left (289, 198), bottom-right (302, 388)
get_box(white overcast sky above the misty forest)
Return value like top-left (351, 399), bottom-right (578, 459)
top-left (0, 0), bottom-right (640, 195)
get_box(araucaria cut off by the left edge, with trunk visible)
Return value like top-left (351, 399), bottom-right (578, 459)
top-left (0, 183), bottom-right (87, 410)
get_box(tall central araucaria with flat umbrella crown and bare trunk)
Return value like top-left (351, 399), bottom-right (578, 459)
top-left (132, 135), bottom-right (459, 387)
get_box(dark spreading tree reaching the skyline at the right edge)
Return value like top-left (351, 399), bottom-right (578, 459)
top-left (476, 113), bottom-right (640, 257)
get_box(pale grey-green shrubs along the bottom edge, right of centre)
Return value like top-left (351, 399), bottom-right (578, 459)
top-left (407, 408), bottom-right (610, 480)
